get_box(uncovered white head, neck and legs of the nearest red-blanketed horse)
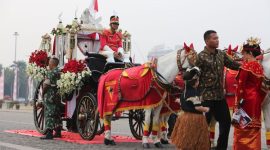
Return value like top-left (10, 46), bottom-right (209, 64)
top-left (98, 42), bottom-right (196, 148)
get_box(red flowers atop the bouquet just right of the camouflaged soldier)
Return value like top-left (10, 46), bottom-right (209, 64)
top-left (62, 60), bottom-right (86, 74)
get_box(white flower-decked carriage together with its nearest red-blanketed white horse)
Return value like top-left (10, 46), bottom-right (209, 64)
top-left (28, 5), bottom-right (200, 147)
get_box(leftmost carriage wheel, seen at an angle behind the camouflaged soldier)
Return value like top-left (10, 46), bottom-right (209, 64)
top-left (33, 81), bottom-right (47, 134)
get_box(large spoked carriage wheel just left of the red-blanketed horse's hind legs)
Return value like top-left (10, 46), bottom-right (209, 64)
top-left (76, 93), bottom-right (98, 140)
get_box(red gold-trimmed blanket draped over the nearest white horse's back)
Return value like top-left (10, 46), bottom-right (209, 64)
top-left (97, 64), bottom-right (167, 118)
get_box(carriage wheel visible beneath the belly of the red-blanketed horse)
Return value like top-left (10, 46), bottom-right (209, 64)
top-left (129, 109), bottom-right (153, 140)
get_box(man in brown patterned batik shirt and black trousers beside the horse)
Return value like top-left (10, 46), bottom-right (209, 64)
top-left (196, 30), bottom-right (240, 150)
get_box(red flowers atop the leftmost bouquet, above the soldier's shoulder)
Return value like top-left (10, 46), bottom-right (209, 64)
top-left (29, 50), bottom-right (48, 68)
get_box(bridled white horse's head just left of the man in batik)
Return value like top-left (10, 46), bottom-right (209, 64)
top-left (177, 43), bottom-right (197, 71)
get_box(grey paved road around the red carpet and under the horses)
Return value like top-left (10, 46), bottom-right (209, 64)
top-left (0, 109), bottom-right (266, 150)
